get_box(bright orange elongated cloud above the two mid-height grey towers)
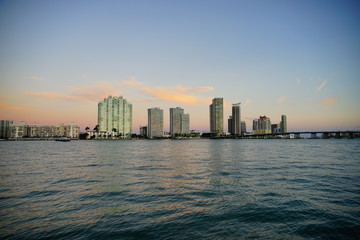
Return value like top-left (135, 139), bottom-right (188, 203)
top-left (141, 86), bottom-right (214, 105)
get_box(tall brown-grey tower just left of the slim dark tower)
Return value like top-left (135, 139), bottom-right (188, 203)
top-left (210, 98), bottom-right (224, 134)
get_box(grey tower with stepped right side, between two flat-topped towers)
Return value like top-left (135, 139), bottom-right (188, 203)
top-left (170, 107), bottom-right (190, 137)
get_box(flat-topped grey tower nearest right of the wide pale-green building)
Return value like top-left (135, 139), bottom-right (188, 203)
top-left (148, 108), bottom-right (164, 138)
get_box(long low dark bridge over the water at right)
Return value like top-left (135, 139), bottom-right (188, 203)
top-left (212, 131), bottom-right (360, 139)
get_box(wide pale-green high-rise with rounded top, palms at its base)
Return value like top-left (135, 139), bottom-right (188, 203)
top-left (98, 96), bottom-right (132, 137)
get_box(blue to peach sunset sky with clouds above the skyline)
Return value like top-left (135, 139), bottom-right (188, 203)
top-left (0, 0), bottom-right (360, 132)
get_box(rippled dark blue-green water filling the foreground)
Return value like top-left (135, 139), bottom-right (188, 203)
top-left (0, 139), bottom-right (360, 239)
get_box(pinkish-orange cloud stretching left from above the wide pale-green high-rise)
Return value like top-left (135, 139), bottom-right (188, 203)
top-left (26, 81), bottom-right (120, 102)
